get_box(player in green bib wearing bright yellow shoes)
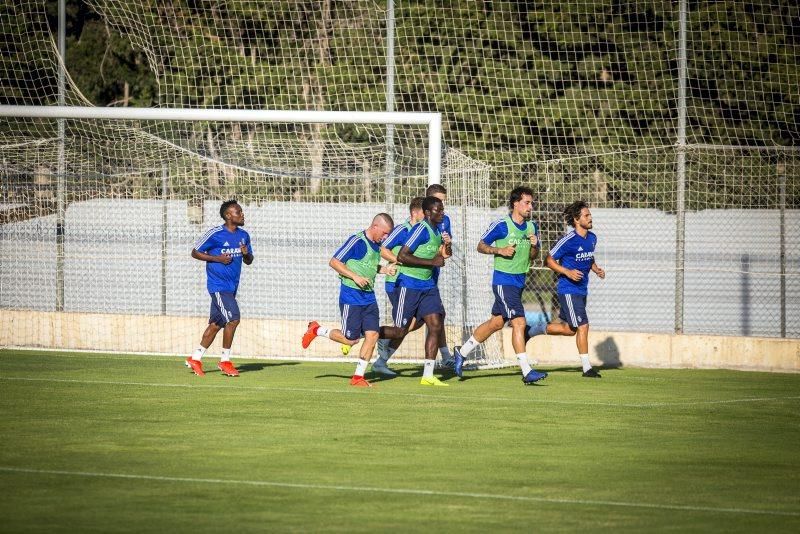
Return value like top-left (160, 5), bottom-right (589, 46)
top-left (390, 196), bottom-right (450, 386)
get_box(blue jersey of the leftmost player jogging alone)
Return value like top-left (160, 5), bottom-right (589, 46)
top-left (194, 225), bottom-right (253, 293)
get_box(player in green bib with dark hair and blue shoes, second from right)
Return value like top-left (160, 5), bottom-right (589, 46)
top-left (454, 187), bottom-right (547, 384)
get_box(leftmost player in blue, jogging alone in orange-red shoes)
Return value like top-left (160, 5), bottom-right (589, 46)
top-left (186, 200), bottom-right (253, 376)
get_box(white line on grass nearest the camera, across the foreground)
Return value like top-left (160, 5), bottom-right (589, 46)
top-left (0, 467), bottom-right (800, 517)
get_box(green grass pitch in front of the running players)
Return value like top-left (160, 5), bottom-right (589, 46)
top-left (0, 350), bottom-right (800, 533)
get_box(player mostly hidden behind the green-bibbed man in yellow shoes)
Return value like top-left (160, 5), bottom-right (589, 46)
top-left (372, 197), bottom-right (425, 376)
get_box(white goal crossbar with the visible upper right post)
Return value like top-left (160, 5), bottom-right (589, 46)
top-left (0, 105), bottom-right (442, 184)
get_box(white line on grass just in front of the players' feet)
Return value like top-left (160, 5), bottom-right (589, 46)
top-left (0, 376), bottom-right (800, 408)
